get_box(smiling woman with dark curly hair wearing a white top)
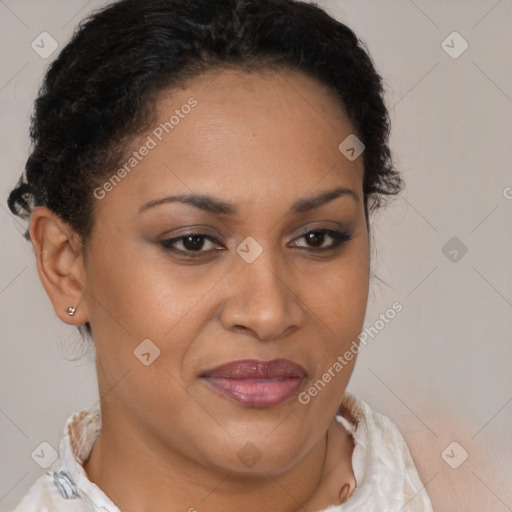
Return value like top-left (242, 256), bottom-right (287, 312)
top-left (8, 0), bottom-right (432, 512)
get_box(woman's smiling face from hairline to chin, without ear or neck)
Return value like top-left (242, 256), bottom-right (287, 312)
top-left (79, 70), bottom-right (369, 473)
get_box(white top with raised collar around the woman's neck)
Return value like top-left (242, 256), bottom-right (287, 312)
top-left (12, 392), bottom-right (433, 512)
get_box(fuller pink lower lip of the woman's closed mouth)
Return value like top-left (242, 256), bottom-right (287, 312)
top-left (203, 377), bottom-right (304, 407)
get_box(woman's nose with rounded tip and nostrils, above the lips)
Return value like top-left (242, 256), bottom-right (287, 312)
top-left (220, 251), bottom-right (305, 341)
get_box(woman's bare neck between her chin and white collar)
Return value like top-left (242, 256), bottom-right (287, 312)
top-left (84, 407), bottom-right (353, 512)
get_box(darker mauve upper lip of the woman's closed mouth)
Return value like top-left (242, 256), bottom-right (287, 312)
top-left (201, 359), bottom-right (306, 379)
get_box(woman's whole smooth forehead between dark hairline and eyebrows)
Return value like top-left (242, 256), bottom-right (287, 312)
top-left (94, 69), bottom-right (363, 214)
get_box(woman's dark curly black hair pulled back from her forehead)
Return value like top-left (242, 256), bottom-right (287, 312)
top-left (8, 0), bottom-right (404, 344)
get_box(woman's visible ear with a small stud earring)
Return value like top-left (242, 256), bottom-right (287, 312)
top-left (29, 206), bottom-right (89, 325)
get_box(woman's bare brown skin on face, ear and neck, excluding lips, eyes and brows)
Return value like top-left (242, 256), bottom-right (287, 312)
top-left (30, 69), bottom-right (370, 512)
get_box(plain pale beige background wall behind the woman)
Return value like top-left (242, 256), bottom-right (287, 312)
top-left (0, 0), bottom-right (512, 512)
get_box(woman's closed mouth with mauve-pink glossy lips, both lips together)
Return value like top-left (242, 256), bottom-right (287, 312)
top-left (200, 359), bottom-right (307, 408)
